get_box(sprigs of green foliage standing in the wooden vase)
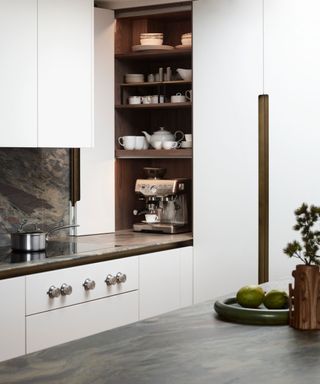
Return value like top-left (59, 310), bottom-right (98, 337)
top-left (283, 203), bottom-right (320, 265)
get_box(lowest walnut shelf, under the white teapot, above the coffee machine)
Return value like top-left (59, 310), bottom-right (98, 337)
top-left (116, 148), bottom-right (192, 159)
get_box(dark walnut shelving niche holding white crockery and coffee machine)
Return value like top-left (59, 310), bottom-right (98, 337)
top-left (115, 2), bottom-right (193, 229)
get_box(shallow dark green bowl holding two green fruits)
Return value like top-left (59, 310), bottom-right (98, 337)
top-left (214, 297), bottom-right (289, 325)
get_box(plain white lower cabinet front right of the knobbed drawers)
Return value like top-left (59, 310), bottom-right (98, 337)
top-left (139, 247), bottom-right (193, 319)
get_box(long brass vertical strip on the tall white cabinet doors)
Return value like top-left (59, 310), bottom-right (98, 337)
top-left (258, 95), bottom-right (269, 284)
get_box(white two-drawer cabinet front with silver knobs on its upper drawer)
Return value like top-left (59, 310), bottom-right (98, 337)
top-left (26, 256), bottom-right (139, 353)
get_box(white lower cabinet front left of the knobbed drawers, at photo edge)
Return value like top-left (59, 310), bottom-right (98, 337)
top-left (0, 277), bottom-right (25, 361)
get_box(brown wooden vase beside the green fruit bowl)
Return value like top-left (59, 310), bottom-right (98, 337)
top-left (289, 265), bottom-right (320, 330)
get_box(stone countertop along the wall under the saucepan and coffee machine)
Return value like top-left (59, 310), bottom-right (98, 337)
top-left (0, 230), bottom-right (193, 279)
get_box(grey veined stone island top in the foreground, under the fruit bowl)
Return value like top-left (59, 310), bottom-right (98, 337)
top-left (0, 301), bottom-right (320, 384)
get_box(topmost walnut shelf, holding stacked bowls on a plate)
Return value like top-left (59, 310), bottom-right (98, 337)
top-left (115, 48), bottom-right (192, 60)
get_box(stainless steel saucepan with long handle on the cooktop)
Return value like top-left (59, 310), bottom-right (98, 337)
top-left (11, 222), bottom-right (79, 252)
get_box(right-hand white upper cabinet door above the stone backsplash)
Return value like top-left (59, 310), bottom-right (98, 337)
top-left (38, 0), bottom-right (93, 147)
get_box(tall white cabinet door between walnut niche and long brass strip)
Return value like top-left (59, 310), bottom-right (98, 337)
top-left (193, 0), bottom-right (263, 302)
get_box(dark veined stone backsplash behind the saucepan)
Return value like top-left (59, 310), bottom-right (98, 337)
top-left (0, 148), bottom-right (70, 245)
